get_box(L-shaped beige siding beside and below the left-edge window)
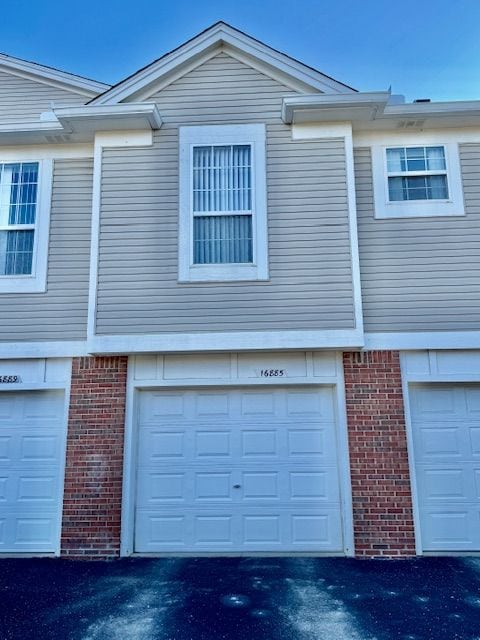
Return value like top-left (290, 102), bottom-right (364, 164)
top-left (0, 159), bottom-right (93, 341)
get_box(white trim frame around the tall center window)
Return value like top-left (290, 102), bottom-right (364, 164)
top-left (178, 124), bottom-right (269, 282)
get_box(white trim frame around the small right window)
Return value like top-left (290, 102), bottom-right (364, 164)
top-left (372, 138), bottom-right (465, 219)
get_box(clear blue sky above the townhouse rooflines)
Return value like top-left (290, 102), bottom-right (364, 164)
top-left (0, 0), bottom-right (480, 100)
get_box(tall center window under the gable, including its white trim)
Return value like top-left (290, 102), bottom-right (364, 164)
top-left (179, 125), bottom-right (268, 281)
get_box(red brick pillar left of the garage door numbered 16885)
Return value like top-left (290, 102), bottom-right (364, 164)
top-left (61, 356), bottom-right (127, 558)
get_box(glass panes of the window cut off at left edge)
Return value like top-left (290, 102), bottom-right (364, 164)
top-left (0, 162), bottom-right (38, 276)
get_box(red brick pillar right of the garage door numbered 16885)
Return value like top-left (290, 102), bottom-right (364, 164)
top-left (343, 351), bottom-right (415, 557)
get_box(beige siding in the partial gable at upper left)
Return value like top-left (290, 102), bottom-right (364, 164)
top-left (0, 71), bottom-right (89, 124)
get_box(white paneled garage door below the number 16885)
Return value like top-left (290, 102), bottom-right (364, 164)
top-left (135, 387), bottom-right (343, 553)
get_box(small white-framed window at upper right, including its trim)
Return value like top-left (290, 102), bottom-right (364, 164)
top-left (372, 143), bottom-right (464, 218)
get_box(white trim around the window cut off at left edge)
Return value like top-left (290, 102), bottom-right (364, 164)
top-left (0, 154), bottom-right (53, 293)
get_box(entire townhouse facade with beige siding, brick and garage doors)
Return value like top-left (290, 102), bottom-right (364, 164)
top-left (0, 23), bottom-right (480, 558)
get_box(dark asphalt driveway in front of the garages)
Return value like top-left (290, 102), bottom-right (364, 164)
top-left (0, 558), bottom-right (480, 640)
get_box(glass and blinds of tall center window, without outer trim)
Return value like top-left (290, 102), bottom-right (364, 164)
top-left (192, 144), bottom-right (253, 264)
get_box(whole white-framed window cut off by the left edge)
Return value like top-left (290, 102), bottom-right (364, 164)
top-left (0, 161), bottom-right (51, 293)
